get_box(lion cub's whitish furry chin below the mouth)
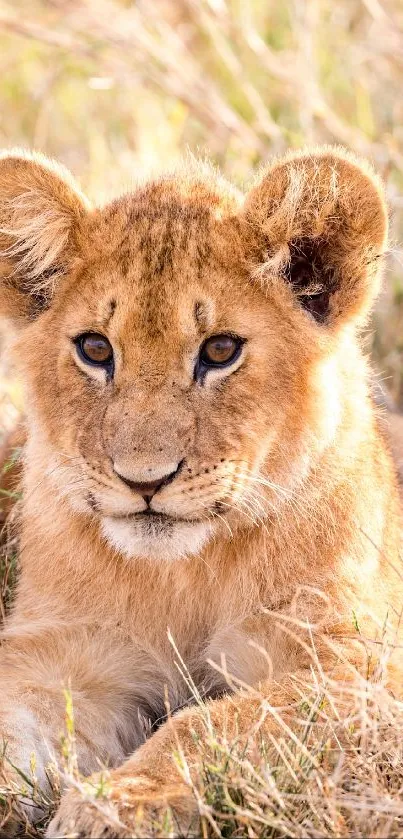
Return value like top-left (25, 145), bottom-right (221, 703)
top-left (102, 516), bottom-right (214, 560)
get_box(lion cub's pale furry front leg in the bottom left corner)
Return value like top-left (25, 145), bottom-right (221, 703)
top-left (0, 623), bottom-right (144, 835)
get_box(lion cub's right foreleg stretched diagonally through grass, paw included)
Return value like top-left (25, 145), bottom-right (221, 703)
top-left (47, 670), bottom-right (318, 839)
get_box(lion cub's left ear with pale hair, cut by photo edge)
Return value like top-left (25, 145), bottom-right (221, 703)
top-left (0, 151), bottom-right (89, 324)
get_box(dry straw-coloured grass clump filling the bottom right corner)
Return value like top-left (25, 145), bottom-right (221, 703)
top-left (178, 678), bottom-right (403, 839)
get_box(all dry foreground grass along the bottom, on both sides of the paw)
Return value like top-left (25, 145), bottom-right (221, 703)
top-left (0, 624), bottom-right (403, 839)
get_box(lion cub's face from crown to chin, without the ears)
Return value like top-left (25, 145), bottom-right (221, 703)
top-left (24, 185), bottom-right (316, 558)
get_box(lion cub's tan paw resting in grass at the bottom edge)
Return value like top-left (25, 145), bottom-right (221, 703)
top-left (46, 773), bottom-right (200, 839)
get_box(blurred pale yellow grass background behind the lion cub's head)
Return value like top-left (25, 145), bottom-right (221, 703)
top-left (0, 0), bottom-right (403, 426)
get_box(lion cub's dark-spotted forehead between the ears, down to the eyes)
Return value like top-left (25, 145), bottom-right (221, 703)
top-left (77, 179), bottom-right (249, 340)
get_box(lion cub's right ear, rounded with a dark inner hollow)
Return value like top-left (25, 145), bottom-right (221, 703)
top-left (243, 147), bottom-right (388, 326)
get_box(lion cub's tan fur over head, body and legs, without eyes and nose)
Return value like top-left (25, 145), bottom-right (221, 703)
top-left (0, 148), bottom-right (403, 836)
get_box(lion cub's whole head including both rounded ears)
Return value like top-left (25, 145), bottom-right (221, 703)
top-left (0, 149), bottom-right (387, 559)
